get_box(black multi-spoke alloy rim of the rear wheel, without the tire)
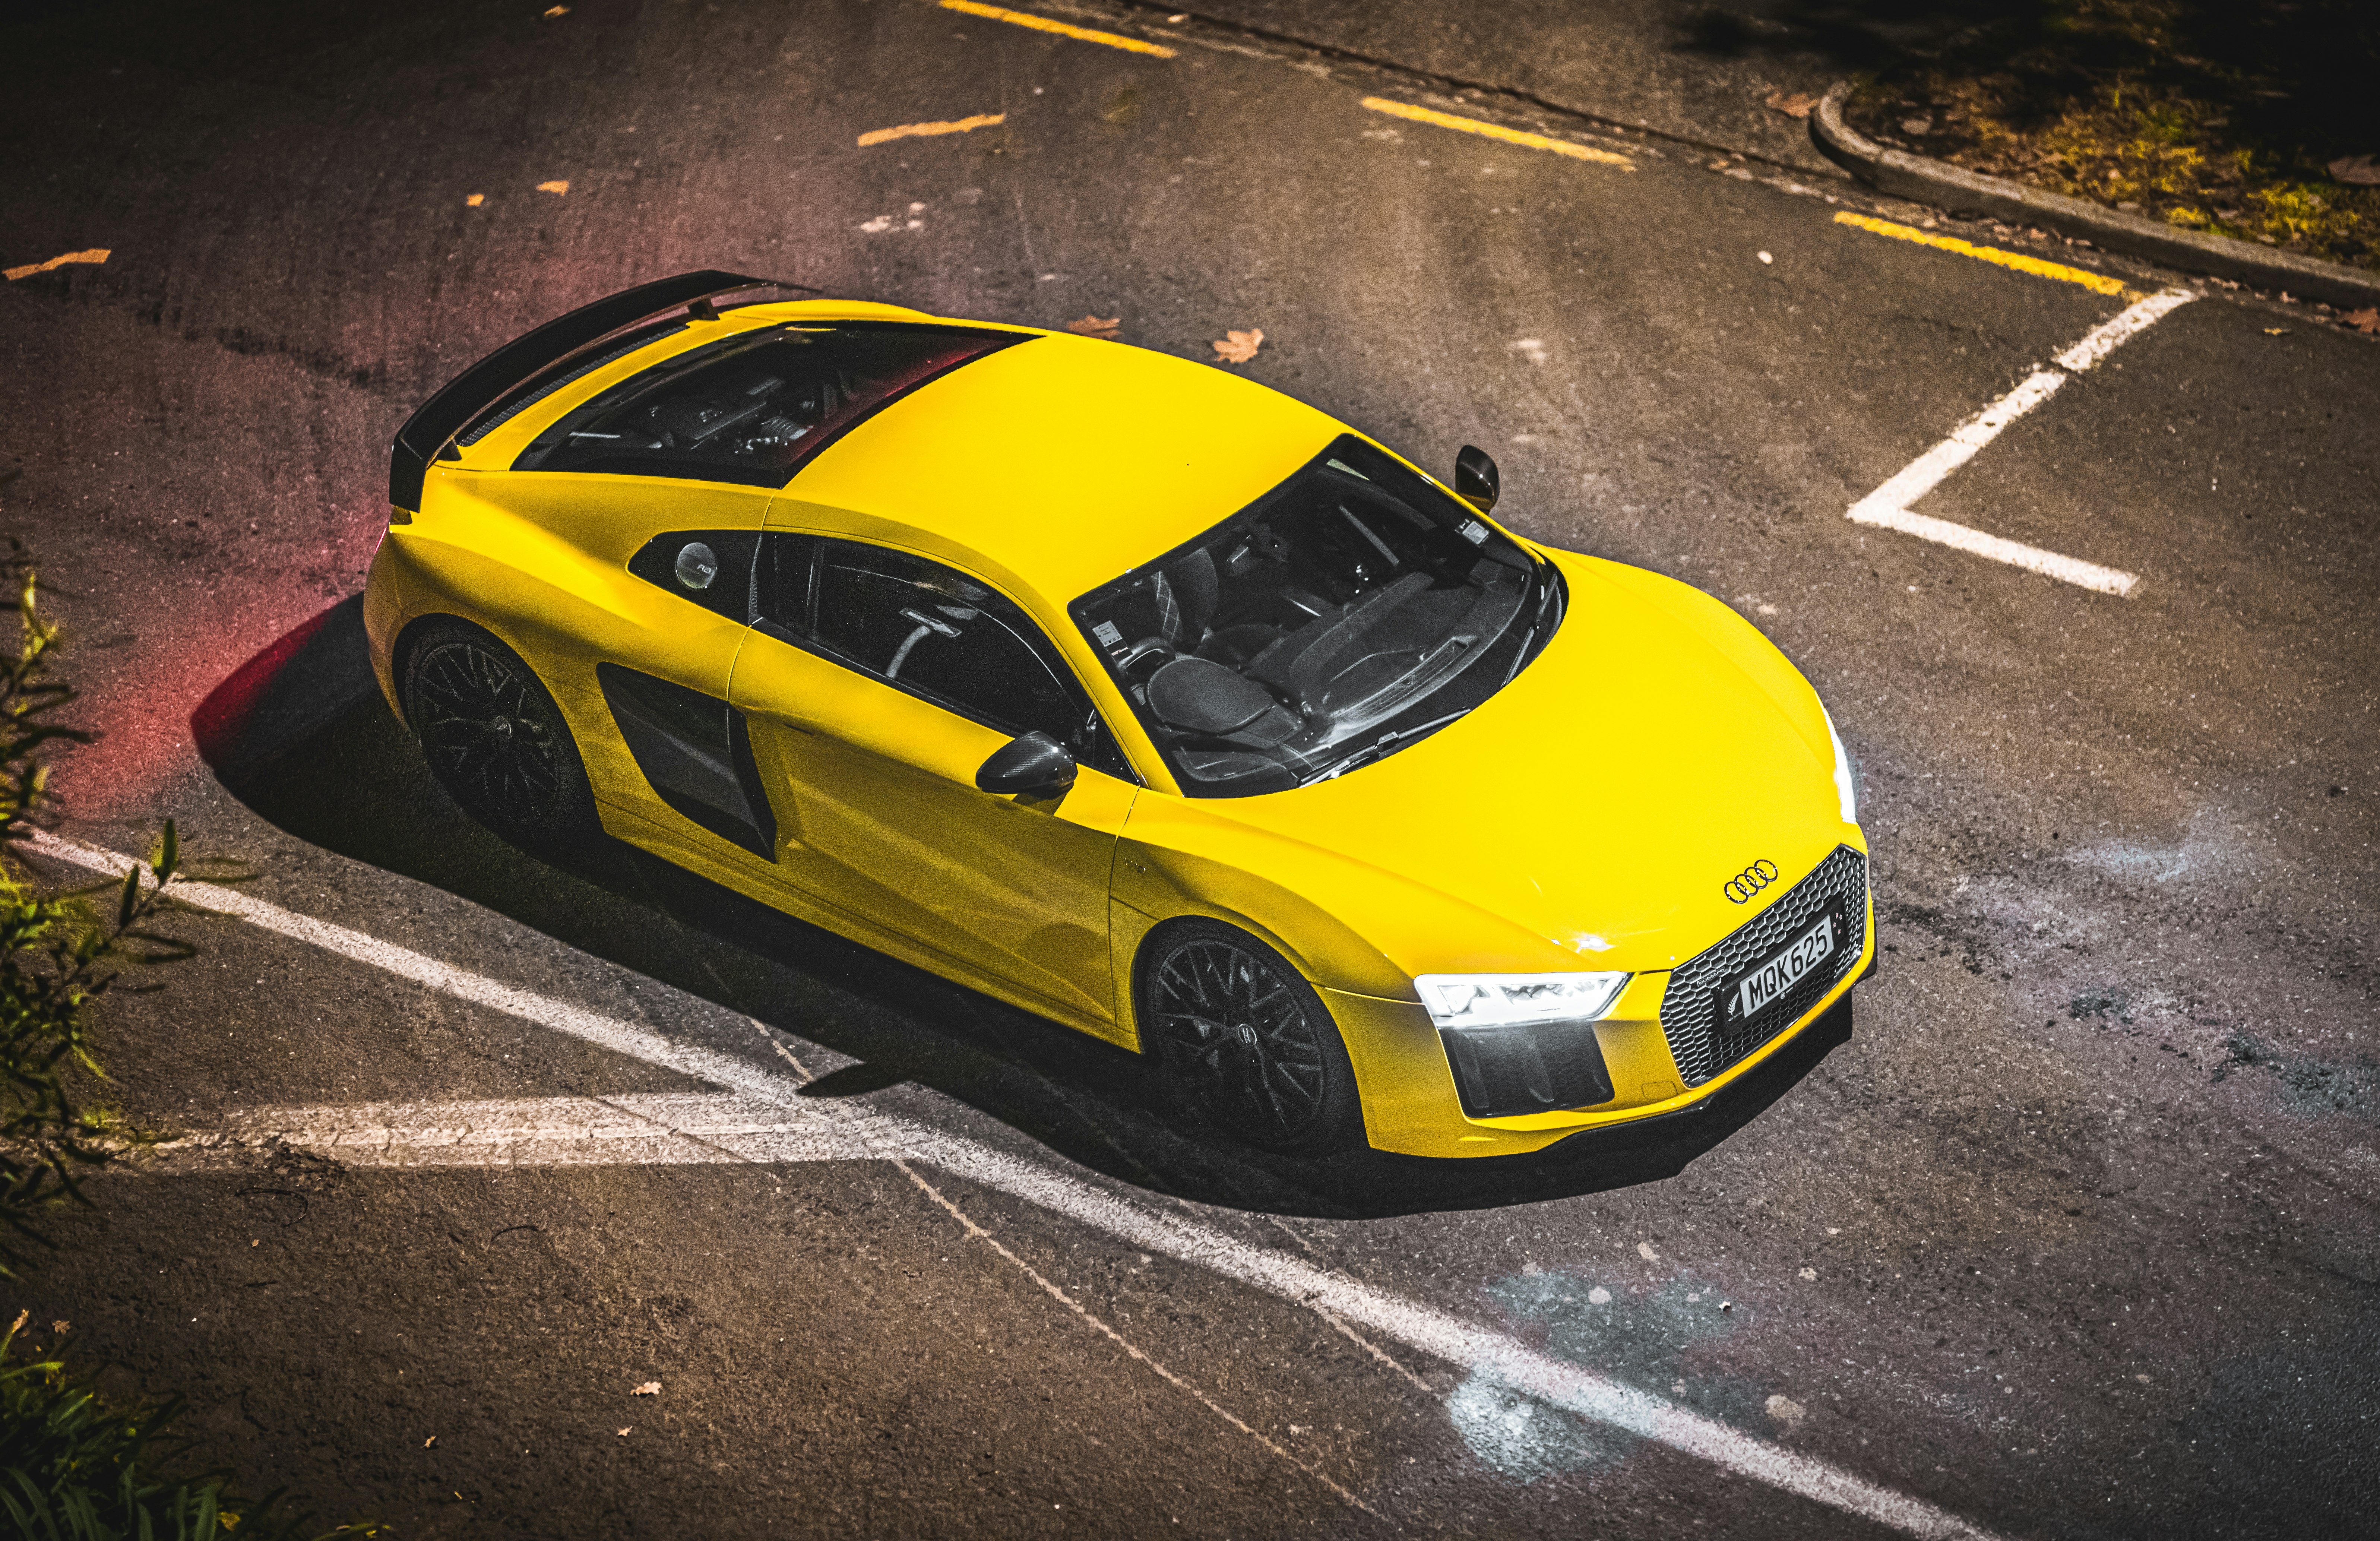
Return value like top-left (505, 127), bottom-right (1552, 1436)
top-left (414, 643), bottom-right (562, 826)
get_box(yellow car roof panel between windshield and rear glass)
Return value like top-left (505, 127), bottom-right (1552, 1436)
top-left (771, 329), bottom-right (1347, 605)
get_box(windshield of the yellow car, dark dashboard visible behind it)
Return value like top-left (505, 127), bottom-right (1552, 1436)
top-left (1071, 433), bottom-right (1561, 798)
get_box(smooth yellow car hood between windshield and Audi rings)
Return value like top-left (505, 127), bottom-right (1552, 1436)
top-left (1207, 553), bottom-right (1861, 972)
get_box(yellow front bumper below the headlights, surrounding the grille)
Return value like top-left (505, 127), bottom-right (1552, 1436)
top-left (1321, 867), bottom-right (1876, 1158)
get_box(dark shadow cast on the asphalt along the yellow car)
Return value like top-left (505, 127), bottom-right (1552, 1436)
top-left (190, 598), bottom-right (1852, 1217)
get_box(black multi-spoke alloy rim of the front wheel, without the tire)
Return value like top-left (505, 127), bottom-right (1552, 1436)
top-left (1149, 941), bottom-right (1323, 1143)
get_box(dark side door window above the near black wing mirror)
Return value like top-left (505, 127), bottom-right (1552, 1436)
top-left (757, 536), bottom-right (1133, 781)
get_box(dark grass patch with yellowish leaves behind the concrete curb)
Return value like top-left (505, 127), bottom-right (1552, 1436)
top-left (1847, 0), bottom-right (2380, 269)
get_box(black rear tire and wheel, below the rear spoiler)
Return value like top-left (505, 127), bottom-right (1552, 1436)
top-left (402, 621), bottom-right (597, 855)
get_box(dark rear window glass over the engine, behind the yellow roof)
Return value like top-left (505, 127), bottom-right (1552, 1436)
top-left (512, 322), bottom-right (1026, 486)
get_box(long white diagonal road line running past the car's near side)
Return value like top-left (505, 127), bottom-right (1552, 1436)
top-left (26, 831), bottom-right (1994, 1541)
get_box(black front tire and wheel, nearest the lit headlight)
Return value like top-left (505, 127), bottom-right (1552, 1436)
top-left (1133, 920), bottom-right (1364, 1155)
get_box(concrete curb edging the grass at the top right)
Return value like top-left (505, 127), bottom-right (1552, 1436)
top-left (1809, 81), bottom-right (2380, 310)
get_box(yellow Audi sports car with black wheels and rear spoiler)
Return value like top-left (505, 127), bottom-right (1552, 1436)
top-left (364, 272), bottom-right (1876, 1155)
